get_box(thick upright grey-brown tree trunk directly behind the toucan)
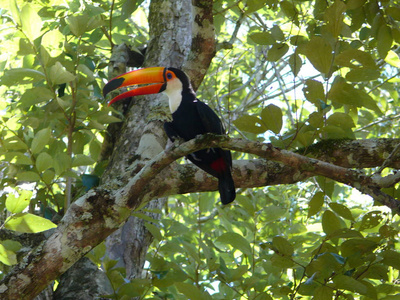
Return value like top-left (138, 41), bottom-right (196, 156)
top-left (103, 0), bottom-right (193, 278)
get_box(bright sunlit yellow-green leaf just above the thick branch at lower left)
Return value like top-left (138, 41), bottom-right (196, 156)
top-left (5, 213), bottom-right (57, 233)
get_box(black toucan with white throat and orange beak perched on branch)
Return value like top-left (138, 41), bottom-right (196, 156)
top-left (103, 67), bottom-right (236, 204)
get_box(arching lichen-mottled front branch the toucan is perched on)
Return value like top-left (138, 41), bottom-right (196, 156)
top-left (0, 134), bottom-right (400, 299)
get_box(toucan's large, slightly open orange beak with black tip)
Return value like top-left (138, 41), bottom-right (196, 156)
top-left (103, 67), bottom-right (167, 106)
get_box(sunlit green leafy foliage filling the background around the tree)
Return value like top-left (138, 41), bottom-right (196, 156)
top-left (0, 0), bottom-right (400, 300)
